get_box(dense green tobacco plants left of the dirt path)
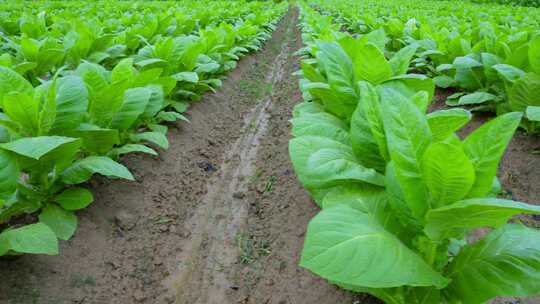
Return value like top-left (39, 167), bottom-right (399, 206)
top-left (0, 1), bottom-right (287, 255)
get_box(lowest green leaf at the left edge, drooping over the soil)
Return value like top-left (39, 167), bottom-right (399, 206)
top-left (0, 223), bottom-right (58, 256)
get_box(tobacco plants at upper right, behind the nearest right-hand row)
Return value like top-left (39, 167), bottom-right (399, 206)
top-left (312, 0), bottom-right (540, 133)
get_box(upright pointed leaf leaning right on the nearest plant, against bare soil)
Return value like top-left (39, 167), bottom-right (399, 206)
top-left (464, 112), bottom-right (522, 198)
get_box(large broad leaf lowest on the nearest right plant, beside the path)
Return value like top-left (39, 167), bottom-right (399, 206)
top-left (300, 205), bottom-right (448, 288)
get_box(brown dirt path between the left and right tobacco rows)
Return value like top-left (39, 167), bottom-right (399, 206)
top-left (0, 11), bottom-right (358, 304)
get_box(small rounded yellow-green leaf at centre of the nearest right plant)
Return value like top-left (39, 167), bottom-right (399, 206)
top-left (422, 142), bottom-right (475, 207)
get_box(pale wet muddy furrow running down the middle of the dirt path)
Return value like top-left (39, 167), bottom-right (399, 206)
top-left (168, 8), bottom-right (293, 304)
